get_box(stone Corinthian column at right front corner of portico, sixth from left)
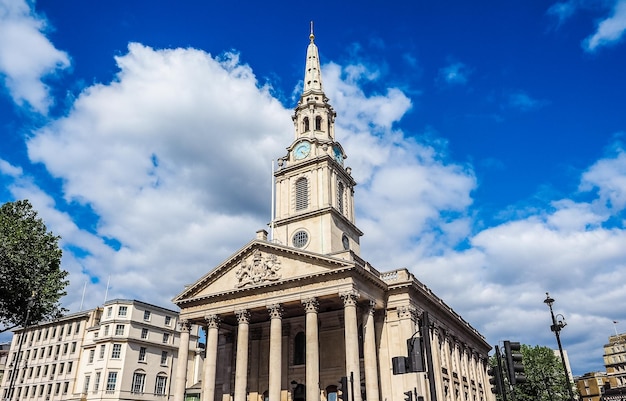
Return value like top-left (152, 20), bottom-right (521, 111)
top-left (339, 291), bottom-right (361, 401)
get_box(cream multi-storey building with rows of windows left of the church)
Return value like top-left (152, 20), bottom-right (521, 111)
top-left (2, 299), bottom-right (201, 401)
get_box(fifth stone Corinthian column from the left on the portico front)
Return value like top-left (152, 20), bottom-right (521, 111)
top-left (302, 298), bottom-right (320, 401)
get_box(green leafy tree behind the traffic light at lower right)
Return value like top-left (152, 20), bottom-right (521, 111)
top-left (490, 344), bottom-right (571, 401)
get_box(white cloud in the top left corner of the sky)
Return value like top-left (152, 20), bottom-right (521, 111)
top-left (0, 0), bottom-right (70, 114)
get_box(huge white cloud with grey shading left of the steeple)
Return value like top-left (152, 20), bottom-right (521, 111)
top-left (22, 44), bottom-right (292, 305)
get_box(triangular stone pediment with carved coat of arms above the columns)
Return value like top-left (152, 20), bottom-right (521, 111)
top-left (173, 240), bottom-right (354, 304)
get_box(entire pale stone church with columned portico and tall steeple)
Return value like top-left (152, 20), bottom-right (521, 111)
top-left (173, 31), bottom-right (494, 401)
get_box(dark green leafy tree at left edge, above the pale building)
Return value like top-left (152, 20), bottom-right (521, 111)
top-left (0, 200), bottom-right (68, 333)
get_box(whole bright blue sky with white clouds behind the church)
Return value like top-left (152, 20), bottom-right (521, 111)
top-left (0, 0), bottom-right (626, 374)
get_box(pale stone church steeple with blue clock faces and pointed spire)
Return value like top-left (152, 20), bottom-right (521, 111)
top-left (272, 24), bottom-right (363, 257)
